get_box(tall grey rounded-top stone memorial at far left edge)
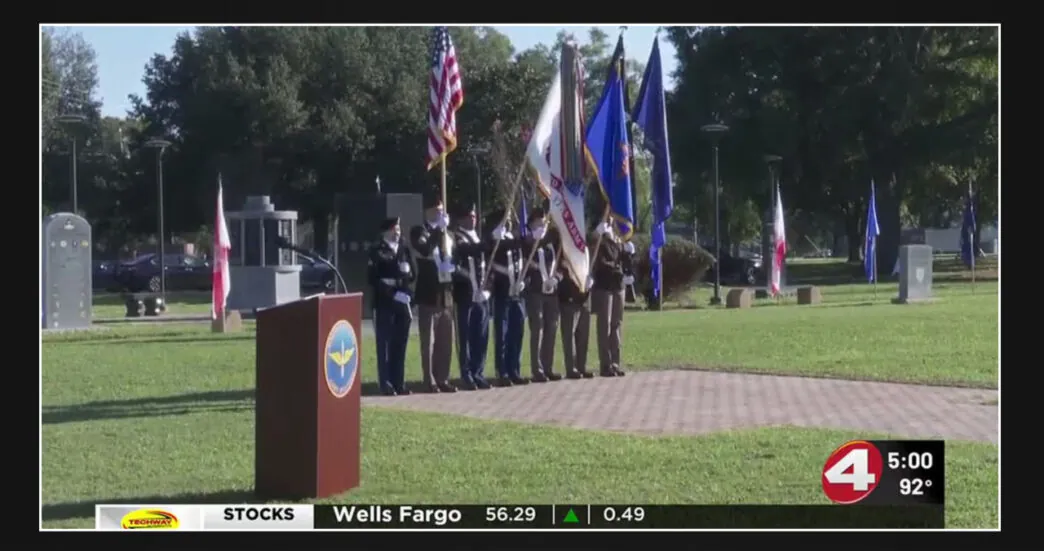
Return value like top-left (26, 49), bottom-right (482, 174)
top-left (41, 213), bottom-right (93, 329)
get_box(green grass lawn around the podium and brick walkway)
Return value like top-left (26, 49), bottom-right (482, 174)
top-left (43, 258), bottom-right (998, 528)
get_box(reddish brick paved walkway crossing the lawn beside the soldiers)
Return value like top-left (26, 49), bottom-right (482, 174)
top-left (363, 370), bottom-right (998, 444)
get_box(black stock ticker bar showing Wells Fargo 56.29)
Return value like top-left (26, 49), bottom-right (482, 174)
top-left (314, 504), bottom-right (945, 530)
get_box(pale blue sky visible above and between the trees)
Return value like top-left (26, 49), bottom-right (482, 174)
top-left (55, 25), bottom-right (677, 117)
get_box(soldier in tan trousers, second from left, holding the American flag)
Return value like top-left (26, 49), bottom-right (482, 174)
top-left (409, 194), bottom-right (456, 392)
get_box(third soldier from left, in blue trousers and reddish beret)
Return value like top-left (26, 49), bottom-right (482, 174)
top-left (453, 206), bottom-right (490, 390)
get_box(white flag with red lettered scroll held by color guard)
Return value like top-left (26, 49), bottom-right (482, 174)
top-left (526, 71), bottom-right (591, 289)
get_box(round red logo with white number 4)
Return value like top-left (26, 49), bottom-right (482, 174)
top-left (823, 440), bottom-right (884, 505)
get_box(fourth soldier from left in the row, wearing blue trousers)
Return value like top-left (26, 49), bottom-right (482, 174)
top-left (485, 210), bottom-right (529, 386)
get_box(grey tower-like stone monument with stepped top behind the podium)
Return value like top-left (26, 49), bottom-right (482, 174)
top-left (226, 195), bottom-right (301, 311)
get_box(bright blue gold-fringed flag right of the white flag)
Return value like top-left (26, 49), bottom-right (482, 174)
top-left (586, 56), bottom-right (635, 240)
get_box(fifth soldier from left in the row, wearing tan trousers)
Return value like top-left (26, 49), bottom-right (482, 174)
top-left (522, 208), bottom-right (562, 383)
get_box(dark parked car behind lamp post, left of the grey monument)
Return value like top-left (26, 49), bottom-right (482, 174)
top-left (115, 254), bottom-right (212, 292)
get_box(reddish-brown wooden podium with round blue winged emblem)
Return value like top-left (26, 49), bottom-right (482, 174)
top-left (254, 293), bottom-right (362, 500)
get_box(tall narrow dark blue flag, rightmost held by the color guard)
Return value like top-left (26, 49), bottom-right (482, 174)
top-left (633, 39), bottom-right (674, 296)
